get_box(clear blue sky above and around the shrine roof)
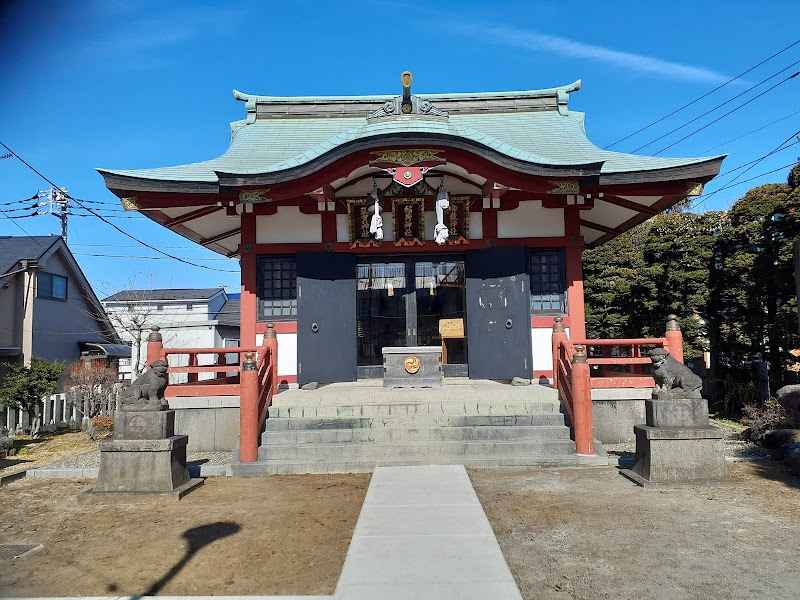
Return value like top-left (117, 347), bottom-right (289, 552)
top-left (0, 0), bottom-right (800, 295)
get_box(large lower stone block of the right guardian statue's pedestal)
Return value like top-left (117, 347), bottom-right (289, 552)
top-left (621, 425), bottom-right (730, 485)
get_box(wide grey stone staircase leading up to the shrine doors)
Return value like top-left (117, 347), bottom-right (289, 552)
top-left (231, 379), bottom-right (607, 475)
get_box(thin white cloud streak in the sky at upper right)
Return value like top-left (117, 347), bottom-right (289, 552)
top-left (445, 23), bottom-right (730, 83)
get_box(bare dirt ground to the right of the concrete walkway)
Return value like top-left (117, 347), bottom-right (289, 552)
top-left (470, 462), bottom-right (800, 600)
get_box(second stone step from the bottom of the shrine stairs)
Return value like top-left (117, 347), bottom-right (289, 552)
top-left (258, 437), bottom-right (575, 464)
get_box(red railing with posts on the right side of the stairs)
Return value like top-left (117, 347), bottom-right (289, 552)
top-left (552, 315), bottom-right (683, 455)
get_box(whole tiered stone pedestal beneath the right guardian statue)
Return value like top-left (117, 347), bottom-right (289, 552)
top-left (621, 398), bottom-right (730, 486)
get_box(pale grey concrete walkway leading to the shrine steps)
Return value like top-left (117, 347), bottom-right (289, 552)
top-left (335, 465), bottom-right (522, 600)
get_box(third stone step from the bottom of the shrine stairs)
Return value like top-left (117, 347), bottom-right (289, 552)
top-left (261, 424), bottom-right (569, 446)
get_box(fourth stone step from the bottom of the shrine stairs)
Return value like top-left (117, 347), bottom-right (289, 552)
top-left (266, 410), bottom-right (564, 431)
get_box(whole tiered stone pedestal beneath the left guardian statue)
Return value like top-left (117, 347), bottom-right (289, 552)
top-left (79, 410), bottom-right (203, 503)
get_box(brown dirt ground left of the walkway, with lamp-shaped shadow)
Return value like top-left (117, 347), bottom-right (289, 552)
top-left (0, 474), bottom-right (370, 597)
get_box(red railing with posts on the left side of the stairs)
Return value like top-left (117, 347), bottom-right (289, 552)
top-left (147, 323), bottom-right (278, 462)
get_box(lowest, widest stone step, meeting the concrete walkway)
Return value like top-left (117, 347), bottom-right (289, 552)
top-left (230, 454), bottom-right (609, 477)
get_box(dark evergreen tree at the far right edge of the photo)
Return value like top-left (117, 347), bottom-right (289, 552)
top-left (709, 167), bottom-right (800, 389)
